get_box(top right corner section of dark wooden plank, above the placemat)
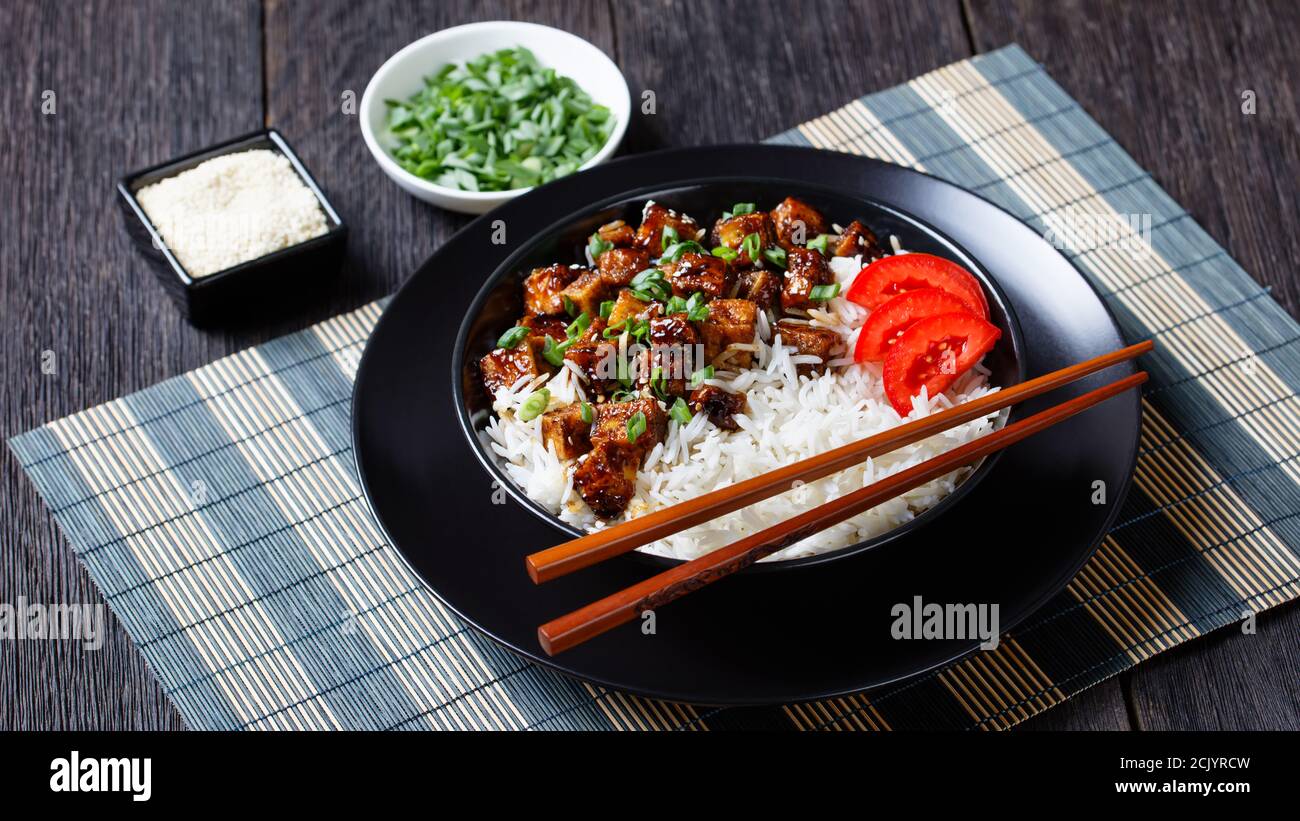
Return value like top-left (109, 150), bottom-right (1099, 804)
top-left (969, 0), bottom-right (1300, 316)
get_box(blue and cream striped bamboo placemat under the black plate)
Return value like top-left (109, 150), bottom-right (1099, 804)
top-left (9, 45), bottom-right (1300, 730)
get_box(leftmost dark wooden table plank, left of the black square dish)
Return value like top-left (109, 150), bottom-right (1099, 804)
top-left (0, 0), bottom-right (261, 729)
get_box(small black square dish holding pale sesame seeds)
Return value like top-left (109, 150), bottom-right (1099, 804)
top-left (117, 129), bottom-right (347, 325)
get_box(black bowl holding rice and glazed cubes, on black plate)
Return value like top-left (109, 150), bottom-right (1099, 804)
top-left (451, 177), bottom-right (1024, 573)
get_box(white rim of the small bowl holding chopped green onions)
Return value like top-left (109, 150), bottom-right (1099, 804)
top-left (358, 19), bottom-right (632, 204)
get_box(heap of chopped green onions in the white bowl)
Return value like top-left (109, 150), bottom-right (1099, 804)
top-left (385, 47), bottom-right (615, 191)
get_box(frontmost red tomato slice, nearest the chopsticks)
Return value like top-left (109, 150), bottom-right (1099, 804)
top-left (884, 313), bottom-right (1002, 416)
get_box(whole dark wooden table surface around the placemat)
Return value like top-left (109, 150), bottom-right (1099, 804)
top-left (0, 0), bottom-right (1300, 730)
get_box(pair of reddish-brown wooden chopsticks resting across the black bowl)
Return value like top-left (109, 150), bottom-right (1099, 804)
top-left (525, 340), bottom-right (1153, 656)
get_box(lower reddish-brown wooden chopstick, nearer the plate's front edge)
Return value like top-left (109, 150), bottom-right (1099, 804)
top-left (537, 372), bottom-right (1147, 656)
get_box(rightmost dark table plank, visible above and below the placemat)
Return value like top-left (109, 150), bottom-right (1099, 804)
top-left (969, 0), bottom-right (1300, 730)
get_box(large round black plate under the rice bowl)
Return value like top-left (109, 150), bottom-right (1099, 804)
top-left (352, 145), bottom-right (1139, 704)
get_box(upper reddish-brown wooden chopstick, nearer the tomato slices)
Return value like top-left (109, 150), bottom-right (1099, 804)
top-left (524, 340), bottom-right (1152, 585)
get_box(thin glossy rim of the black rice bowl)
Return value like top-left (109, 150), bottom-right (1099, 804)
top-left (450, 175), bottom-right (1027, 573)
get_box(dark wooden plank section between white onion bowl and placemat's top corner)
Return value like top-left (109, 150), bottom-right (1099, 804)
top-left (614, 0), bottom-right (971, 151)
